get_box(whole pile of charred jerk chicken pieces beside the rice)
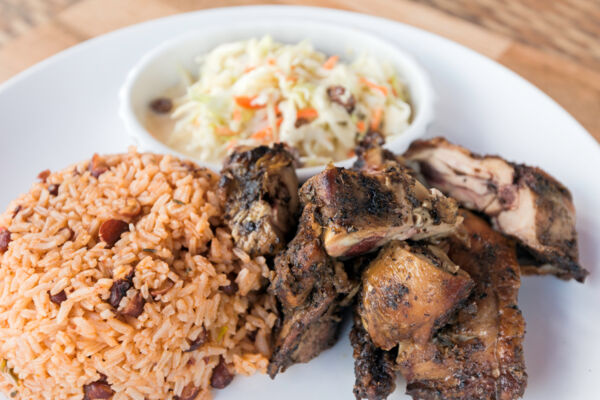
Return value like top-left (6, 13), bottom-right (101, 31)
top-left (220, 134), bottom-right (576, 400)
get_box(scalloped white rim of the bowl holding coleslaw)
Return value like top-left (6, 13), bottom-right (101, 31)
top-left (119, 18), bottom-right (435, 179)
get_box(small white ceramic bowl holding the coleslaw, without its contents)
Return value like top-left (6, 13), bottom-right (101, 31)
top-left (119, 19), bottom-right (434, 181)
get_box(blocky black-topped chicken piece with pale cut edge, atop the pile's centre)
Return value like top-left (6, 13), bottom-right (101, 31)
top-left (300, 162), bottom-right (461, 257)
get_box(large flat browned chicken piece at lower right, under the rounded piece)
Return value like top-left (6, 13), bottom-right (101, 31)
top-left (396, 212), bottom-right (527, 400)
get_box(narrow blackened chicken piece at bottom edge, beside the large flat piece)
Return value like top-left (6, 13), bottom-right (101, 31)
top-left (350, 312), bottom-right (396, 400)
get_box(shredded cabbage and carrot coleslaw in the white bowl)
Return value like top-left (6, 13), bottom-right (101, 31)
top-left (147, 36), bottom-right (411, 166)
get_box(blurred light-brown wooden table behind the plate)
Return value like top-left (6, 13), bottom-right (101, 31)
top-left (0, 0), bottom-right (600, 141)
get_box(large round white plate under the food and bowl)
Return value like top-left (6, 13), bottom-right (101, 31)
top-left (0, 6), bottom-right (600, 400)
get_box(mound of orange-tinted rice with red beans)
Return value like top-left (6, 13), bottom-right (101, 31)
top-left (0, 150), bottom-right (277, 400)
